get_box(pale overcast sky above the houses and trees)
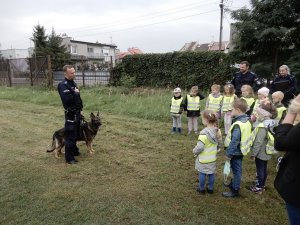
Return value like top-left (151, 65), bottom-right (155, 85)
top-left (0, 0), bottom-right (249, 53)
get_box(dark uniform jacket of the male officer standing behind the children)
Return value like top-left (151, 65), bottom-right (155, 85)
top-left (231, 71), bottom-right (257, 93)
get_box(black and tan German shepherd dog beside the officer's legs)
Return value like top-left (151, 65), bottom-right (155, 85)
top-left (47, 112), bottom-right (102, 158)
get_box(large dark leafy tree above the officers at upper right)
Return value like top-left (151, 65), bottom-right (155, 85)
top-left (231, 0), bottom-right (300, 78)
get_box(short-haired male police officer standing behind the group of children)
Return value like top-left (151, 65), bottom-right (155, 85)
top-left (231, 61), bottom-right (264, 97)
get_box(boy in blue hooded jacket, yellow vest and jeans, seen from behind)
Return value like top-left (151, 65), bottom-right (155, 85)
top-left (222, 99), bottom-right (251, 198)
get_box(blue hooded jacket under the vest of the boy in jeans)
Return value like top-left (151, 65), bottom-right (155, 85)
top-left (225, 114), bottom-right (249, 158)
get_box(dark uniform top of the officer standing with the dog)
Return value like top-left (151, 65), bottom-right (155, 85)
top-left (57, 78), bottom-right (83, 111)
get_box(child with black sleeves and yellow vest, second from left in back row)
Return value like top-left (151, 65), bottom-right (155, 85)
top-left (184, 86), bottom-right (205, 134)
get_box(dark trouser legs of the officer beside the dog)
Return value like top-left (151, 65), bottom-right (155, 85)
top-left (65, 121), bottom-right (78, 162)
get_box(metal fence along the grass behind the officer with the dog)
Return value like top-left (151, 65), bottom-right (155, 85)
top-left (0, 56), bottom-right (110, 86)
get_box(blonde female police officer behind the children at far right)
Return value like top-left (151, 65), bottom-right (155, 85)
top-left (270, 65), bottom-right (297, 107)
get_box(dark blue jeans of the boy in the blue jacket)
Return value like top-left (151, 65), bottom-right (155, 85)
top-left (230, 156), bottom-right (243, 193)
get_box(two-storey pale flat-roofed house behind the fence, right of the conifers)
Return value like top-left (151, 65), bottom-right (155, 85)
top-left (62, 34), bottom-right (117, 70)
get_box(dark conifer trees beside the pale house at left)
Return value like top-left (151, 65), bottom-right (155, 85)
top-left (31, 24), bottom-right (71, 70)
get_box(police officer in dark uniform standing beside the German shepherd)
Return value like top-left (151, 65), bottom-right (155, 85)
top-left (57, 65), bottom-right (83, 164)
